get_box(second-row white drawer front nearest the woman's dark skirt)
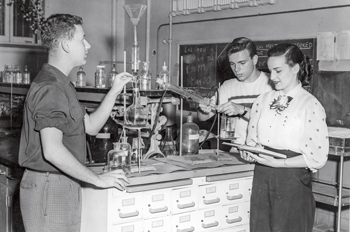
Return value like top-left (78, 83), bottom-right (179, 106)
top-left (222, 202), bottom-right (250, 228)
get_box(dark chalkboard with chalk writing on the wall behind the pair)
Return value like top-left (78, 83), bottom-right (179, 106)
top-left (179, 38), bottom-right (316, 110)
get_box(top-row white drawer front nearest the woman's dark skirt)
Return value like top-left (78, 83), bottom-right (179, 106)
top-left (221, 179), bottom-right (252, 205)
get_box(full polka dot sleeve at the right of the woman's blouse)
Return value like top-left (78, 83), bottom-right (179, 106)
top-left (299, 99), bottom-right (329, 171)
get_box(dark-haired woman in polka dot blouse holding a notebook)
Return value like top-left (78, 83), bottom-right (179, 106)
top-left (241, 43), bottom-right (329, 232)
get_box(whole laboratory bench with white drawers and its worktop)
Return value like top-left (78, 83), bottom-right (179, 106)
top-left (82, 150), bottom-right (254, 232)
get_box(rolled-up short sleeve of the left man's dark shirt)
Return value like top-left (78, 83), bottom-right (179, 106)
top-left (30, 85), bottom-right (69, 133)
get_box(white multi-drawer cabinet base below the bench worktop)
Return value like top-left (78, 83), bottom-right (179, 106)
top-left (82, 171), bottom-right (252, 232)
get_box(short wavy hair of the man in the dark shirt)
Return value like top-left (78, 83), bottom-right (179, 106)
top-left (41, 14), bottom-right (83, 51)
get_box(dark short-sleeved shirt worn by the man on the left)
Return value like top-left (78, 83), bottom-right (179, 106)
top-left (19, 64), bottom-right (86, 172)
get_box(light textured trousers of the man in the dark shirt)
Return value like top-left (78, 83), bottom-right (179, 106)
top-left (20, 169), bottom-right (82, 232)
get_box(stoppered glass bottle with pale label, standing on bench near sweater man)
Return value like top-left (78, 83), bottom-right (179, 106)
top-left (181, 114), bottom-right (199, 155)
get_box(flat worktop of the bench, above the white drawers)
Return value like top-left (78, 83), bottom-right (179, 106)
top-left (86, 150), bottom-right (254, 193)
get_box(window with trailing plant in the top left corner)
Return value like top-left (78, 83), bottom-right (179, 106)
top-left (0, 0), bottom-right (44, 44)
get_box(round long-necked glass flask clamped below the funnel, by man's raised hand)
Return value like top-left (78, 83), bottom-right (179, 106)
top-left (125, 88), bottom-right (148, 127)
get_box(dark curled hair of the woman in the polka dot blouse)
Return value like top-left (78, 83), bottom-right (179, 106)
top-left (267, 43), bottom-right (312, 85)
